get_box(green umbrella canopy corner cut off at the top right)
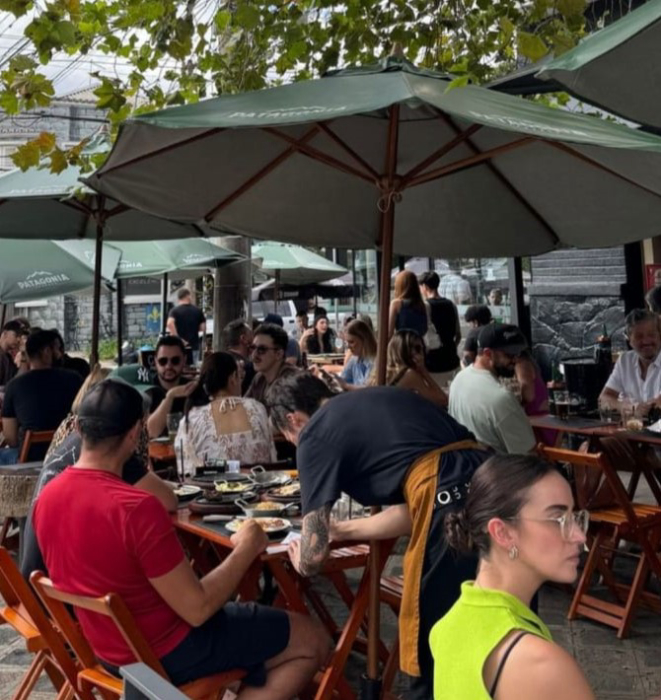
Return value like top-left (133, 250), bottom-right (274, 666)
top-left (536, 0), bottom-right (661, 129)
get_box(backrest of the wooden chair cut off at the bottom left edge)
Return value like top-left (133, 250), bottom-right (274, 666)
top-left (0, 547), bottom-right (84, 700)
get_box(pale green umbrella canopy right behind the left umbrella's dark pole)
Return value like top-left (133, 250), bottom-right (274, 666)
top-left (113, 238), bottom-right (245, 279)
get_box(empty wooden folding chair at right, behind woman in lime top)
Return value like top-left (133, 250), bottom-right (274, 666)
top-left (538, 445), bottom-right (661, 639)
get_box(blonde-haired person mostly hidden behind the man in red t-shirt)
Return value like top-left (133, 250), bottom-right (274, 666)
top-left (20, 364), bottom-right (177, 579)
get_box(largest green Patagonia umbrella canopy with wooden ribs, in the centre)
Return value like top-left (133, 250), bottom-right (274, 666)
top-left (88, 53), bottom-right (661, 258)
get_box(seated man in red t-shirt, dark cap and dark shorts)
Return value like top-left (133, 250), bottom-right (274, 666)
top-left (33, 380), bottom-right (329, 700)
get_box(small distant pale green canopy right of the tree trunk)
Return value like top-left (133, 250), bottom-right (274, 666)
top-left (251, 242), bottom-right (347, 285)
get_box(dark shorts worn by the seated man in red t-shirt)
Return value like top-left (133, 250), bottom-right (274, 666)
top-left (104, 603), bottom-right (289, 686)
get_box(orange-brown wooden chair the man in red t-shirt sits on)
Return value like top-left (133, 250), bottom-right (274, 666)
top-left (30, 571), bottom-right (245, 700)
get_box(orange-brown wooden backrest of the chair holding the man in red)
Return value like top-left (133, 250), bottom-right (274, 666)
top-left (30, 571), bottom-right (168, 678)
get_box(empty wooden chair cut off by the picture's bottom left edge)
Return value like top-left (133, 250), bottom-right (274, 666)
top-left (0, 547), bottom-right (77, 700)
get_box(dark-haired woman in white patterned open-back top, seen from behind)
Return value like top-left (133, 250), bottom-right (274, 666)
top-left (177, 352), bottom-right (276, 466)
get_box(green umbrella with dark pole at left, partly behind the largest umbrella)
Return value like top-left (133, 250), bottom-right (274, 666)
top-left (0, 133), bottom-right (222, 362)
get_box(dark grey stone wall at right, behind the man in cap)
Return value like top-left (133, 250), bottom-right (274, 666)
top-left (528, 247), bottom-right (626, 379)
